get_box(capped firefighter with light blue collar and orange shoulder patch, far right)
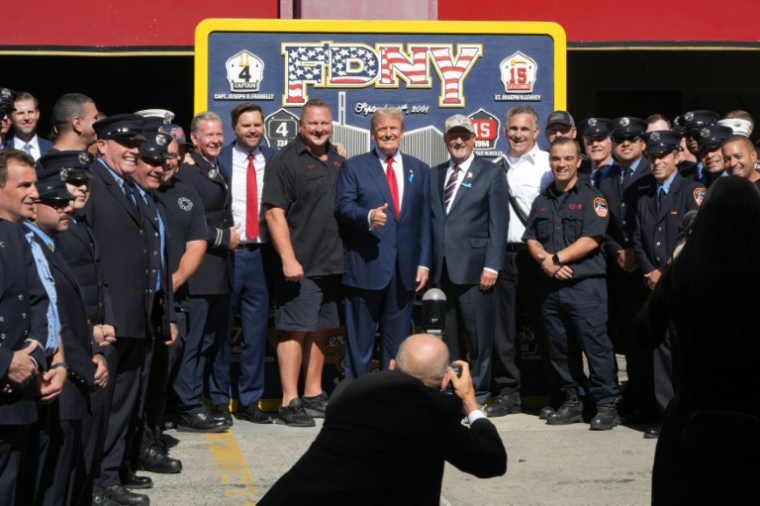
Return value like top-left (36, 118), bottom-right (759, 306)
top-left (633, 130), bottom-right (706, 438)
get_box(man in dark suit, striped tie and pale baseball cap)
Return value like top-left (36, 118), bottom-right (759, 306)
top-left (430, 114), bottom-right (509, 404)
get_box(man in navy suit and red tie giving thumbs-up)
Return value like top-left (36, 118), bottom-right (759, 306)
top-left (335, 109), bottom-right (431, 378)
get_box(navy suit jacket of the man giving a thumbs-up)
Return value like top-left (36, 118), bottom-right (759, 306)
top-left (335, 149), bottom-right (431, 290)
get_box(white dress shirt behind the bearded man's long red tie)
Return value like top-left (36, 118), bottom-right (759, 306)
top-left (232, 143), bottom-right (269, 244)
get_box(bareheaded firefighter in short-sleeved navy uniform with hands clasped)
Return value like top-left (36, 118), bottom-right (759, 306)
top-left (523, 138), bottom-right (619, 430)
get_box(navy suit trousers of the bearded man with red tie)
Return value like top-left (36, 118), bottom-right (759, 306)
top-left (209, 244), bottom-right (271, 406)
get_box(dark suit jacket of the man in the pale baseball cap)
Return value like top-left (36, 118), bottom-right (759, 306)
top-left (430, 156), bottom-right (509, 285)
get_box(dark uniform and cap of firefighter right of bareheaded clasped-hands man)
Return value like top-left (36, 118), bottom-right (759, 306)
top-left (598, 118), bottom-right (658, 422)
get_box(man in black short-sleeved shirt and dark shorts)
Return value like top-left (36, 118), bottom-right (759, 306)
top-left (261, 100), bottom-right (345, 427)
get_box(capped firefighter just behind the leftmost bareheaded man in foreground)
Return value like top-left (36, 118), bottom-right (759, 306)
top-left (25, 164), bottom-right (108, 505)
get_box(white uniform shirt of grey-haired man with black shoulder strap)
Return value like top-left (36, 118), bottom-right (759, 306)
top-left (502, 144), bottom-right (554, 243)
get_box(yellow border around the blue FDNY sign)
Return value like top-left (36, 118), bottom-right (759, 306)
top-left (195, 19), bottom-right (567, 114)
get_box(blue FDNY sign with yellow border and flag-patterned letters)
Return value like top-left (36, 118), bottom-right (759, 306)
top-left (195, 19), bottom-right (566, 165)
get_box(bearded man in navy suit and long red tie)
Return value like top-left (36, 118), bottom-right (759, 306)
top-left (211, 103), bottom-right (277, 423)
